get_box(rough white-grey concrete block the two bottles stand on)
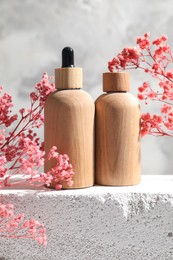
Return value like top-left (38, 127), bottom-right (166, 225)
top-left (0, 176), bottom-right (173, 260)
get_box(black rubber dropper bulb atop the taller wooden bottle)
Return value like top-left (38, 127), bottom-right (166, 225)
top-left (62, 47), bottom-right (74, 68)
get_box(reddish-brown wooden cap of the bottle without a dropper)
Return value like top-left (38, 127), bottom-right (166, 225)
top-left (103, 72), bottom-right (130, 92)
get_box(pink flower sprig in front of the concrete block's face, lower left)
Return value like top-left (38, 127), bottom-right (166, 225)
top-left (0, 203), bottom-right (47, 245)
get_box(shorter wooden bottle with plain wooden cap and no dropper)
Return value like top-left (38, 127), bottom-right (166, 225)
top-left (95, 72), bottom-right (141, 186)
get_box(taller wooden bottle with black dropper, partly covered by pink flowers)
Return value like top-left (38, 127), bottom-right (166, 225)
top-left (44, 47), bottom-right (94, 189)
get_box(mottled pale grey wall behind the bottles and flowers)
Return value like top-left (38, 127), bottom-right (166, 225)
top-left (0, 0), bottom-right (173, 174)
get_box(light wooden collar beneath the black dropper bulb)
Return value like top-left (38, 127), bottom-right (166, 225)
top-left (55, 68), bottom-right (83, 89)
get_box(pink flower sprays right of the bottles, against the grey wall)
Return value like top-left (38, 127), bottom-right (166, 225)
top-left (108, 33), bottom-right (173, 136)
